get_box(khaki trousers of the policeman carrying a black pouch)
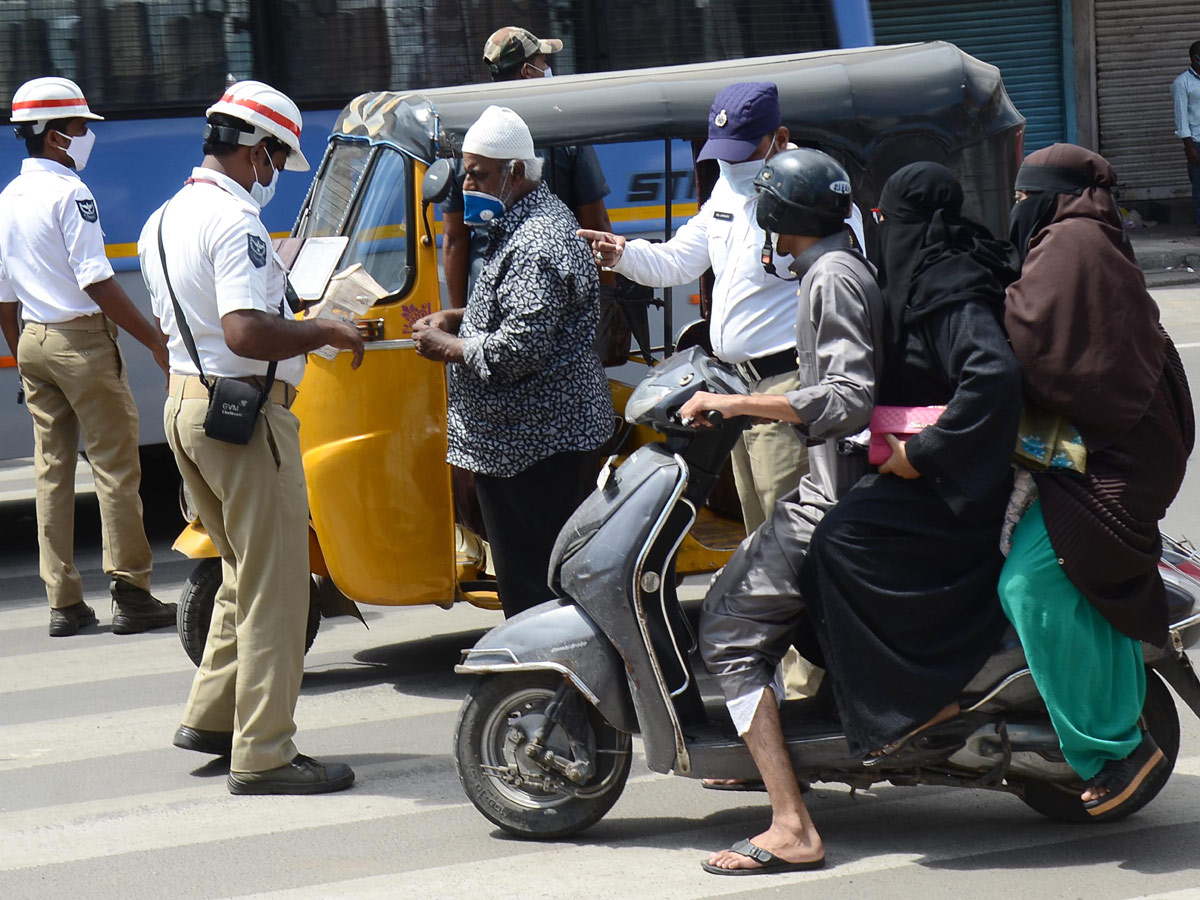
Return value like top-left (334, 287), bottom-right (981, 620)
top-left (163, 376), bottom-right (310, 772)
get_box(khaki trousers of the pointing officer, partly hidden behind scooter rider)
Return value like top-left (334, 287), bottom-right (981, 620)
top-left (733, 372), bottom-right (824, 700)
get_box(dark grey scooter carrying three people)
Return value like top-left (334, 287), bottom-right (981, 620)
top-left (455, 348), bottom-right (1200, 839)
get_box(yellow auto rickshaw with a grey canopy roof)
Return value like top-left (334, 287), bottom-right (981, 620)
top-left (174, 43), bottom-right (1024, 661)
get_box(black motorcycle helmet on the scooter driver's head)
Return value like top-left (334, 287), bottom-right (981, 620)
top-left (754, 148), bottom-right (850, 238)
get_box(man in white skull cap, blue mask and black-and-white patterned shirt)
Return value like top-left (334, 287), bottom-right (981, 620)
top-left (413, 106), bottom-right (613, 616)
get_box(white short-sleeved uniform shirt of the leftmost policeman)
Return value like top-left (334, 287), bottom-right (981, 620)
top-left (0, 157), bottom-right (113, 324)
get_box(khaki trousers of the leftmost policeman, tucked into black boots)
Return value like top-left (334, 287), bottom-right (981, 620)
top-left (17, 313), bottom-right (152, 608)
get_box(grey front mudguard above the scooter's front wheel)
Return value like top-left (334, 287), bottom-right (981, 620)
top-left (454, 600), bottom-right (638, 733)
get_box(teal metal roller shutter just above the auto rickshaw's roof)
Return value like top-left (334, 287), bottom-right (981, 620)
top-left (871, 0), bottom-right (1067, 154)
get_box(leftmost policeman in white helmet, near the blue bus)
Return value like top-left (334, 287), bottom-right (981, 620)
top-left (0, 78), bottom-right (175, 637)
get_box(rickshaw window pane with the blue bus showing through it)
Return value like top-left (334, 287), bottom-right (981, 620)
top-left (342, 148), bottom-right (410, 294)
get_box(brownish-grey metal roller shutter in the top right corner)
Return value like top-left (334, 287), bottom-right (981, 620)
top-left (1094, 0), bottom-right (1200, 200)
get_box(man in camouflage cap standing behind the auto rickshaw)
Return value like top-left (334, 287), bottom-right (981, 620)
top-left (442, 25), bottom-right (616, 321)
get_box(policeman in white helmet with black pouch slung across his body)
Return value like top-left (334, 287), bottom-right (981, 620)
top-left (138, 82), bottom-right (362, 793)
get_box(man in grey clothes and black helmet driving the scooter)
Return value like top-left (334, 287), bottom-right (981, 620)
top-left (679, 149), bottom-right (883, 875)
